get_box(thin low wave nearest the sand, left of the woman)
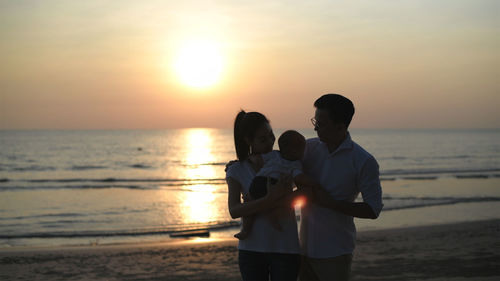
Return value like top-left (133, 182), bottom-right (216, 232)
top-left (0, 221), bottom-right (240, 239)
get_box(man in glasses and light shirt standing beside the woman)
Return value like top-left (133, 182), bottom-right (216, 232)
top-left (299, 94), bottom-right (383, 280)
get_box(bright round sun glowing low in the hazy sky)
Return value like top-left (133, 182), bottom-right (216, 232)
top-left (174, 40), bottom-right (224, 88)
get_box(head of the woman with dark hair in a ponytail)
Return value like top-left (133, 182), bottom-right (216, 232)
top-left (234, 110), bottom-right (275, 161)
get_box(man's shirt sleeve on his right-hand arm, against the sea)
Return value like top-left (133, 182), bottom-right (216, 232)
top-left (359, 157), bottom-right (384, 217)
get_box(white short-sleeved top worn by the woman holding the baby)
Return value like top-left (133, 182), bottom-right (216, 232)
top-left (226, 161), bottom-right (300, 254)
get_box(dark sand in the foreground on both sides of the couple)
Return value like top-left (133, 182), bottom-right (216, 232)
top-left (0, 220), bottom-right (500, 281)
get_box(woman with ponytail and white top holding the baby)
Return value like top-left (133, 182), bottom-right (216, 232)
top-left (226, 111), bottom-right (300, 280)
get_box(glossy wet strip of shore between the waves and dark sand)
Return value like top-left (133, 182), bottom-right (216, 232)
top-left (0, 198), bottom-right (500, 250)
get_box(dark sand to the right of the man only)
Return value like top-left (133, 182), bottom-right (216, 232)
top-left (352, 219), bottom-right (500, 281)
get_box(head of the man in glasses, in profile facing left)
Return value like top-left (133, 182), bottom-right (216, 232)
top-left (312, 94), bottom-right (354, 143)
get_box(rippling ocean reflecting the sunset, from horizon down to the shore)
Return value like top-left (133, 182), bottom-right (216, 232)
top-left (0, 129), bottom-right (500, 248)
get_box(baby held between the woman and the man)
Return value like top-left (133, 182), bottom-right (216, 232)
top-left (234, 130), bottom-right (319, 240)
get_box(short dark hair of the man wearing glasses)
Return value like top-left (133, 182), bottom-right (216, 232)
top-left (314, 94), bottom-right (354, 128)
